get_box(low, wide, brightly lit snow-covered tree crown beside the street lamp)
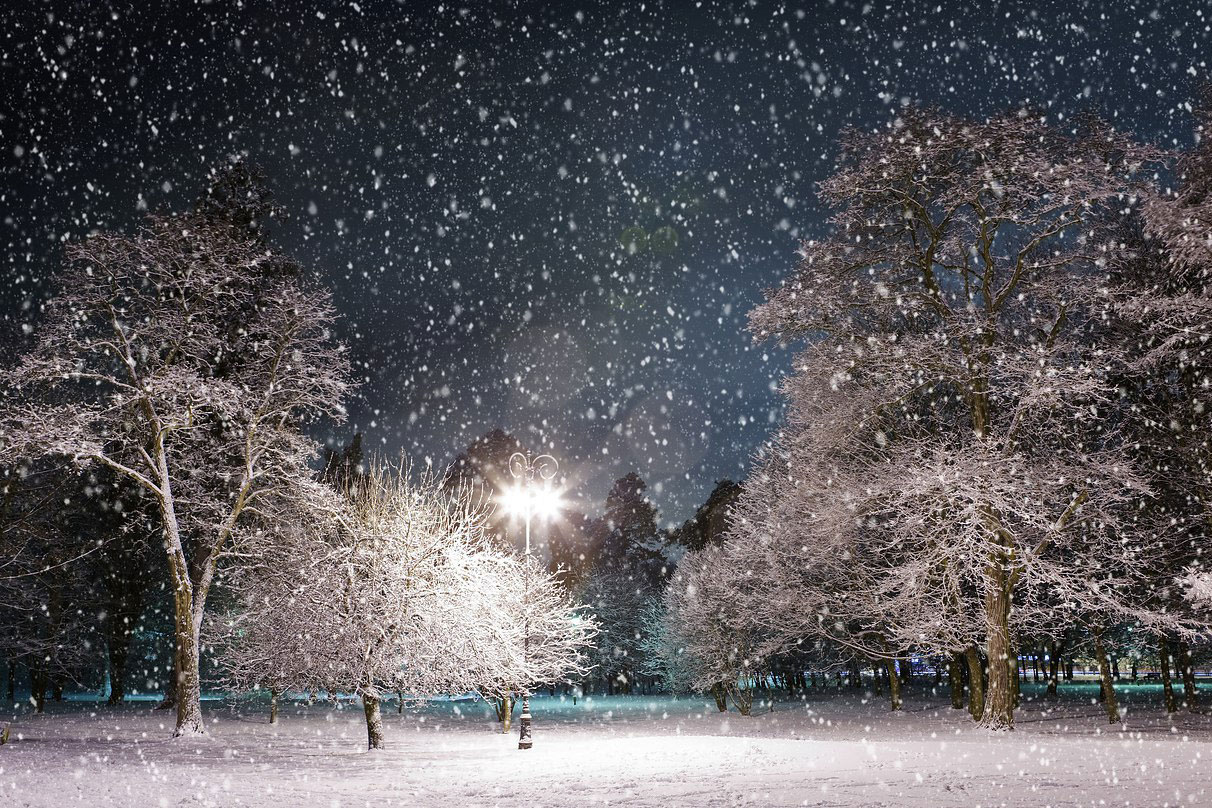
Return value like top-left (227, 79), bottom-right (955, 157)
top-left (215, 462), bottom-right (594, 749)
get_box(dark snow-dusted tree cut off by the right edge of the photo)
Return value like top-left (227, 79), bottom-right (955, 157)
top-left (1111, 98), bottom-right (1212, 711)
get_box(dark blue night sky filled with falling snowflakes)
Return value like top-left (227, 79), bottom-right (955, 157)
top-left (0, 0), bottom-right (1212, 521)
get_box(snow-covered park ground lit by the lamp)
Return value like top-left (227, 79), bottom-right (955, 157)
top-left (0, 684), bottom-right (1212, 808)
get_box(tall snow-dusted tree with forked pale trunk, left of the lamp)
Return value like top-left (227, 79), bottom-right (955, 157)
top-left (2, 175), bottom-right (347, 735)
